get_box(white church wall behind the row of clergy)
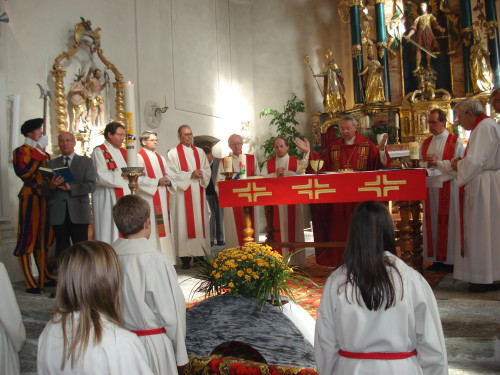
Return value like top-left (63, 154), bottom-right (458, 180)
top-left (0, 0), bottom-right (346, 280)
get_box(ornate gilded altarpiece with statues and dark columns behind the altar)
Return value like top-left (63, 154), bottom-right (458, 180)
top-left (304, 0), bottom-right (500, 270)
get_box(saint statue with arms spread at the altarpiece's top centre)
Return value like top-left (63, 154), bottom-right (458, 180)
top-left (405, 2), bottom-right (446, 70)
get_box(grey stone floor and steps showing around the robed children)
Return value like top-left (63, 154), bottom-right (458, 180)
top-left (14, 245), bottom-right (500, 375)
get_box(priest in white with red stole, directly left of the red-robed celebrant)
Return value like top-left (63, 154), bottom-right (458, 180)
top-left (261, 137), bottom-right (309, 265)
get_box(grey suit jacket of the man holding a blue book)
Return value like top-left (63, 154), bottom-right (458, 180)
top-left (43, 154), bottom-right (96, 225)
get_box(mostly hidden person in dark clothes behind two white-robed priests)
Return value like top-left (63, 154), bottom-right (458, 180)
top-left (202, 146), bottom-right (225, 246)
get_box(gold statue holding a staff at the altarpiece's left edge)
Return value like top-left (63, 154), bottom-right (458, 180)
top-left (314, 50), bottom-right (345, 113)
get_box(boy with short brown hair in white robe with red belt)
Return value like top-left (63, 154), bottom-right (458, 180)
top-left (113, 195), bottom-right (189, 375)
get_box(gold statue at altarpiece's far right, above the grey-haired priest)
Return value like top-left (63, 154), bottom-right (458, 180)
top-left (470, 29), bottom-right (493, 94)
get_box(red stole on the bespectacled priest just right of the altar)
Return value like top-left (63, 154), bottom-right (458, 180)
top-left (422, 133), bottom-right (458, 262)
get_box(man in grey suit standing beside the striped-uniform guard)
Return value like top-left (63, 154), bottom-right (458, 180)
top-left (43, 132), bottom-right (96, 258)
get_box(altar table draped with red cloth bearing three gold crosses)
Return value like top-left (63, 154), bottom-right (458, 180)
top-left (219, 169), bottom-right (426, 272)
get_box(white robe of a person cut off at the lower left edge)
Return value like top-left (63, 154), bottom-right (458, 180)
top-left (0, 262), bottom-right (26, 375)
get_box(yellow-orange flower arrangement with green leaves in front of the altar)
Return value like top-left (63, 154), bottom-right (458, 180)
top-left (195, 242), bottom-right (307, 307)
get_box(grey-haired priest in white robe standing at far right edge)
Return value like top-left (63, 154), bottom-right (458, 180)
top-left (452, 99), bottom-right (500, 292)
